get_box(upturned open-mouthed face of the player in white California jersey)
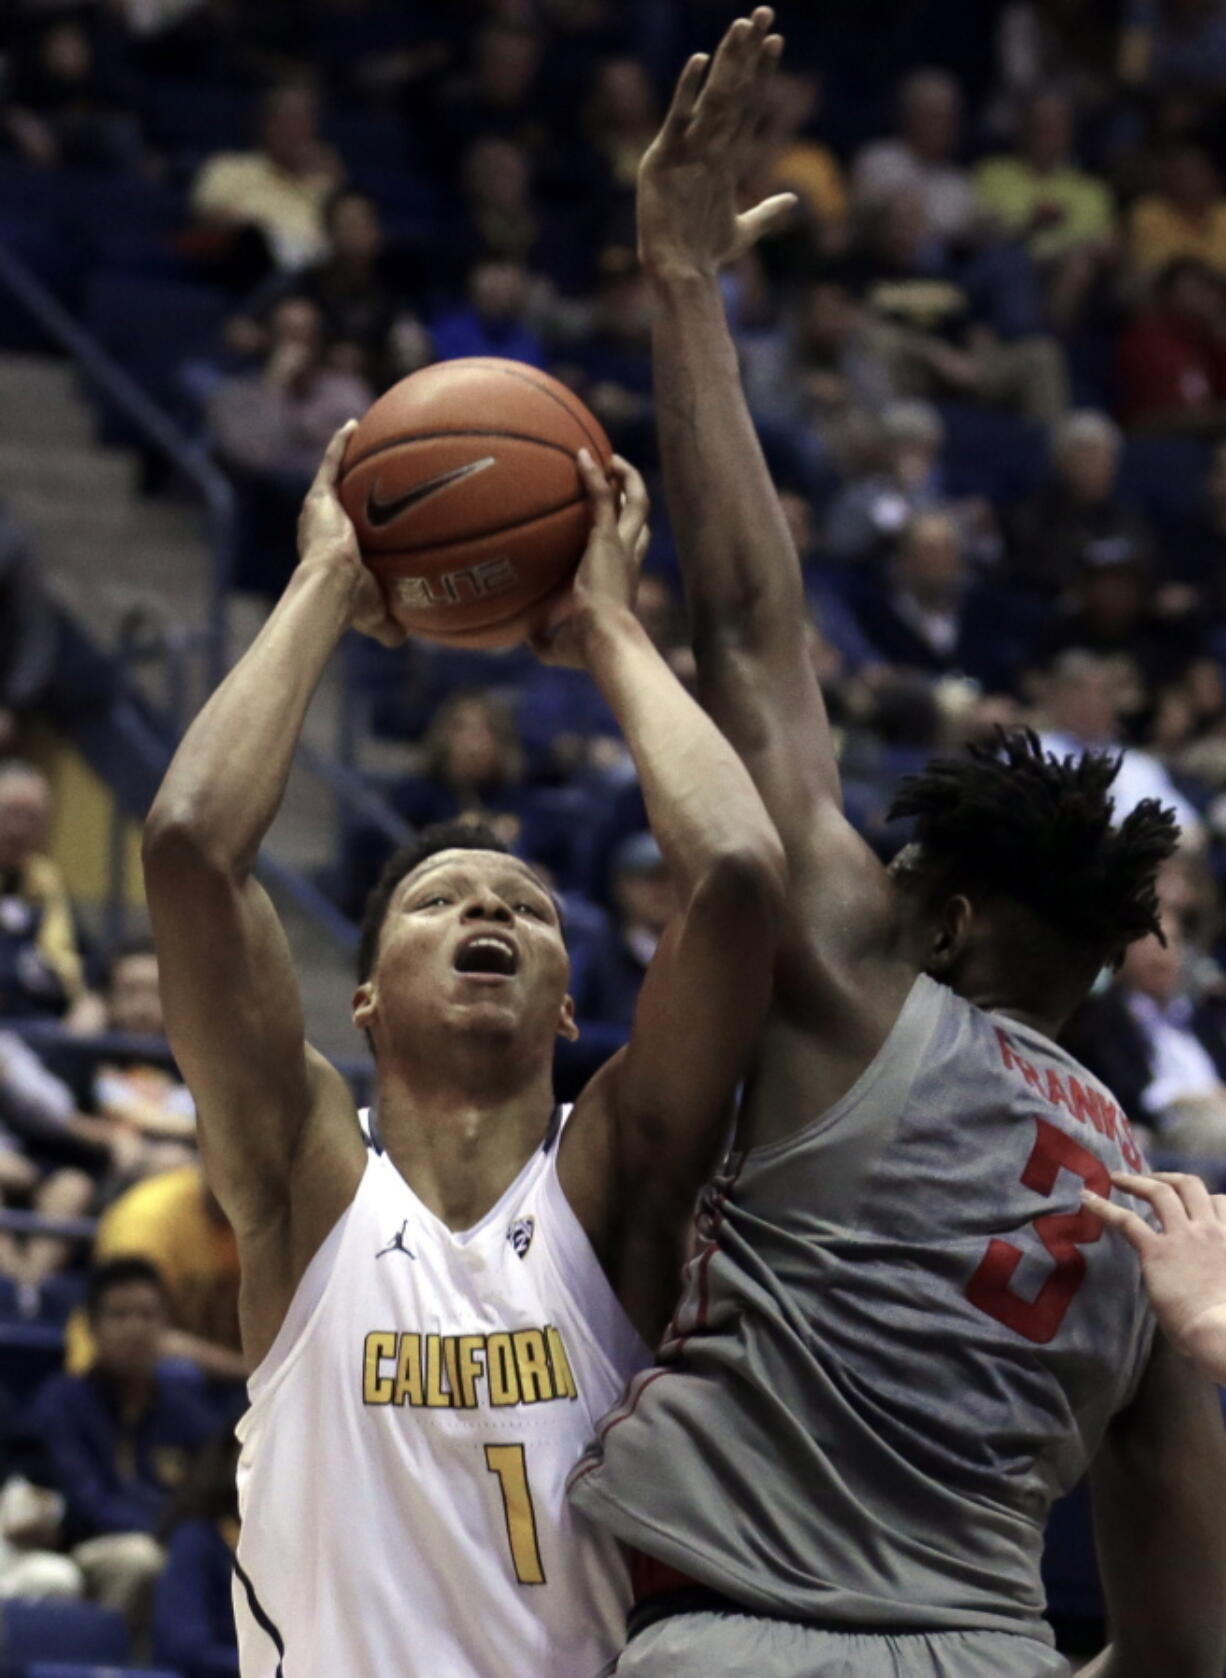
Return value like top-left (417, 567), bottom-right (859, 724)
top-left (356, 851), bottom-right (574, 1045)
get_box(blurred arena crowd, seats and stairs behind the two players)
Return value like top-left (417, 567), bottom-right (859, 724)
top-left (0, 0), bottom-right (1226, 1678)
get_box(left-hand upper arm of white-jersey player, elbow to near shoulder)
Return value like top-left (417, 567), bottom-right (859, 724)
top-left (146, 859), bottom-right (317, 1212)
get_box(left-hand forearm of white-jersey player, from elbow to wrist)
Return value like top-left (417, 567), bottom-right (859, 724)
top-left (146, 564), bottom-right (354, 874)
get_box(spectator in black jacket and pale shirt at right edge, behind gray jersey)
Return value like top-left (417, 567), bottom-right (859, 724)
top-left (1065, 921), bottom-right (1226, 1159)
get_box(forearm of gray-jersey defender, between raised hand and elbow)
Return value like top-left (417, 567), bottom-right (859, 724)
top-left (652, 274), bottom-right (805, 644)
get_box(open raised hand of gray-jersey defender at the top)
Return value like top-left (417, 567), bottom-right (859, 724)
top-left (639, 7), bottom-right (797, 277)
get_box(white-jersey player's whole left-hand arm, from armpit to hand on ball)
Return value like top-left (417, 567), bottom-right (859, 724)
top-left (143, 430), bottom-right (399, 1358)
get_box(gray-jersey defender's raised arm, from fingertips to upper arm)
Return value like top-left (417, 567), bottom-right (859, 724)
top-left (639, 7), bottom-right (839, 832)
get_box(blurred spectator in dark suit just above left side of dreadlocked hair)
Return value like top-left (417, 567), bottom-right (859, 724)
top-left (849, 510), bottom-right (1021, 693)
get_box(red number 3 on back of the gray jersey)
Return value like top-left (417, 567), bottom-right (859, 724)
top-left (966, 1119), bottom-right (1110, 1346)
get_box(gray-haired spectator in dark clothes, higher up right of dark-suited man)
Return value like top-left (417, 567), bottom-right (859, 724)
top-left (1008, 408), bottom-right (1152, 597)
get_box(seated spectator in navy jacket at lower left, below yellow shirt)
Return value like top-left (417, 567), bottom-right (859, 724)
top-left (32, 1257), bottom-right (216, 1626)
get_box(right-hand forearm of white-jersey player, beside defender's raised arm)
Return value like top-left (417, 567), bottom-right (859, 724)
top-left (584, 612), bottom-right (783, 889)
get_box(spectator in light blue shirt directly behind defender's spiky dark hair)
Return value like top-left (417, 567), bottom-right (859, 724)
top-left (1040, 649), bottom-right (1204, 849)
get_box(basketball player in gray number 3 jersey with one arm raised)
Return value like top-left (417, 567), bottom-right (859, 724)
top-left (572, 8), bottom-right (1226, 1678)
